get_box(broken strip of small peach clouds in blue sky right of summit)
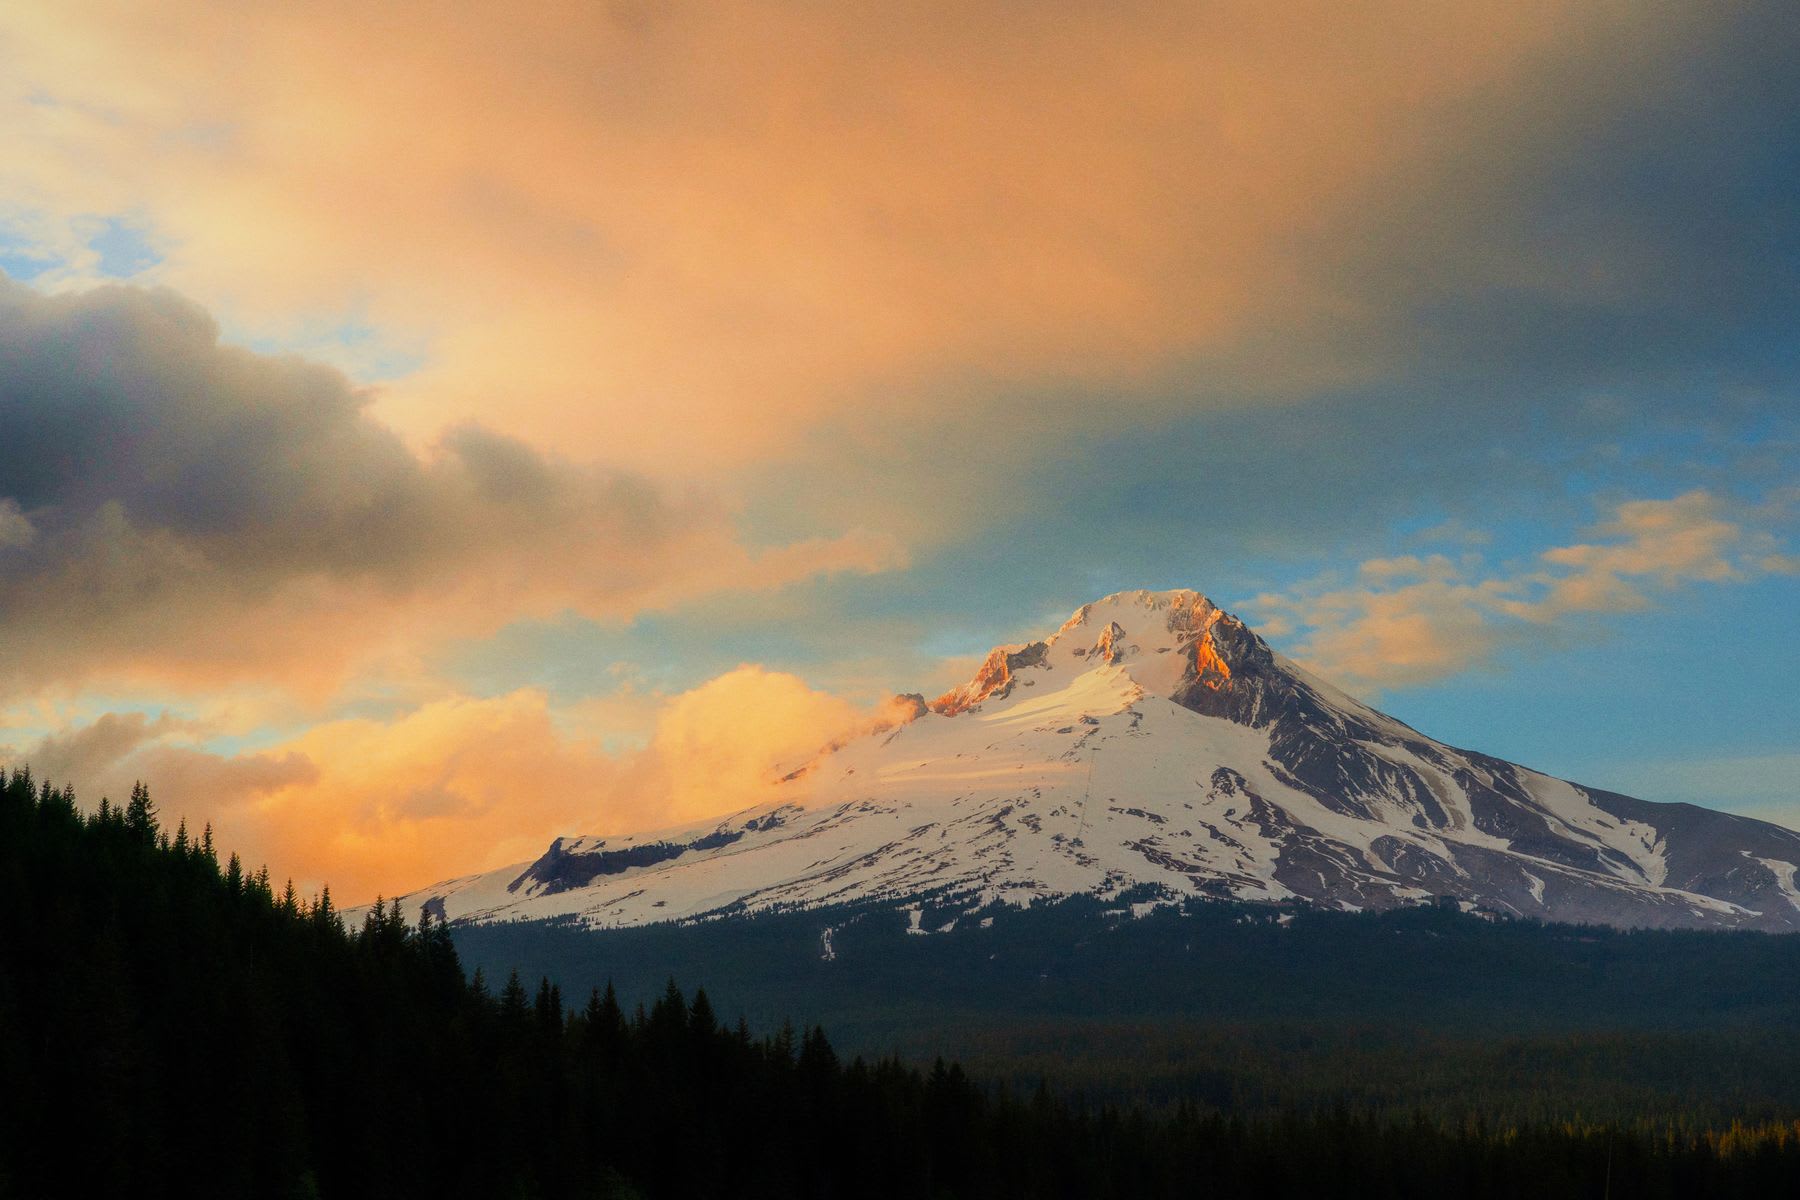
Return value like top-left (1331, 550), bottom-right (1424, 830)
top-left (1251, 489), bottom-right (1786, 689)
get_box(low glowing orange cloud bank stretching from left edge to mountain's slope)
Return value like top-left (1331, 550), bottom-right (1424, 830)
top-left (0, 666), bottom-right (886, 901)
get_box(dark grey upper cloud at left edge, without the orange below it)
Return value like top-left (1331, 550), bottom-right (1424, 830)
top-left (0, 284), bottom-right (680, 587)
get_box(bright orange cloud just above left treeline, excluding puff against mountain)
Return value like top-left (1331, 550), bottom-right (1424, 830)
top-left (1, 693), bottom-right (616, 900)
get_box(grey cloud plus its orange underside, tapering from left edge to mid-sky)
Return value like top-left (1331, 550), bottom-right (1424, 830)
top-left (0, 282), bottom-right (904, 693)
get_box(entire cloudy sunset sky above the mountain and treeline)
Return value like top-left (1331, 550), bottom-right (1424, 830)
top-left (0, 0), bottom-right (1800, 901)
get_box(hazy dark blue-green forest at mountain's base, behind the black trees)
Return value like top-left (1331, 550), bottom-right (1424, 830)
top-left (450, 898), bottom-right (1800, 1128)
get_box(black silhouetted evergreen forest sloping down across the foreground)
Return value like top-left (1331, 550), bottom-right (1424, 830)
top-left (0, 770), bottom-right (1800, 1198)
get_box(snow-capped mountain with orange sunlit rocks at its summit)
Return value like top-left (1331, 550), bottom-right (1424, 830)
top-left (390, 590), bottom-right (1800, 930)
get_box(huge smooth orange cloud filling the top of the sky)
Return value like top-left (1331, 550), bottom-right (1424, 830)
top-left (0, 0), bottom-right (1679, 479)
